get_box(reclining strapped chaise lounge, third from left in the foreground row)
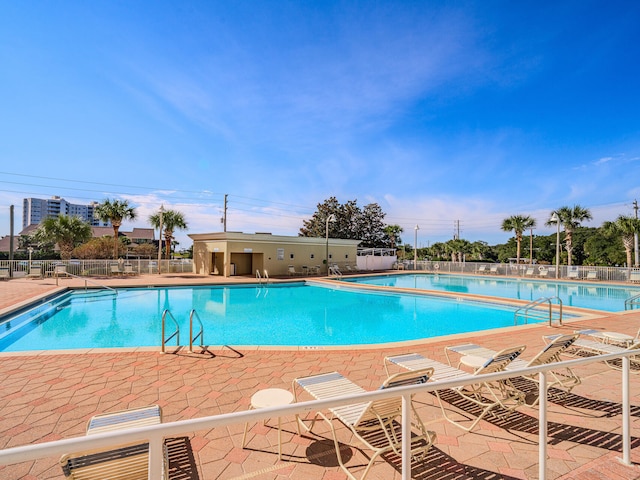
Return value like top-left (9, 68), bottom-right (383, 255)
top-left (384, 345), bottom-right (525, 432)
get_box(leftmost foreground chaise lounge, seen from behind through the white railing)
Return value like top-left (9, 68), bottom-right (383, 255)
top-left (60, 405), bottom-right (162, 480)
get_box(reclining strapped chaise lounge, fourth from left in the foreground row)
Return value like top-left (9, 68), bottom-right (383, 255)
top-left (445, 333), bottom-right (581, 405)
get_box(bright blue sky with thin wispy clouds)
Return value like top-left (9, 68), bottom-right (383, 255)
top-left (0, 0), bottom-right (640, 247)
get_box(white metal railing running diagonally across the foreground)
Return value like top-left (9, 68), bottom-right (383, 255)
top-left (0, 351), bottom-right (638, 480)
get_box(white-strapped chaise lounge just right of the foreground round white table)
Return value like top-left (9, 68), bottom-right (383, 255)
top-left (293, 368), bottom-right (436, 480)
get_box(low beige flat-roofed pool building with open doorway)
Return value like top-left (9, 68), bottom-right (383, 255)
top-left (189, 232), bottom-right (360, 277)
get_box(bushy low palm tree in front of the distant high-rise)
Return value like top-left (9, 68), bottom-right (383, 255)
top-left (33, 215), bottom-right (91, 260)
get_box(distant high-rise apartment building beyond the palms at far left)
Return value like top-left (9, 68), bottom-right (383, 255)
top-left (22, 197), bottom-right (111, 229)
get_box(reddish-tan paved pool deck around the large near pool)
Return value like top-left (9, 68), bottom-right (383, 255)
top-left (0, 274), bottom-right (640, 480)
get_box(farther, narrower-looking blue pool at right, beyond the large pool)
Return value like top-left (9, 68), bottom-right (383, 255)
top-left (344, 274), bottom-right (640, 312)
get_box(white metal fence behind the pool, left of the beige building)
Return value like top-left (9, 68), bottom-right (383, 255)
top-left (0, 258), bottom-right (193, 278)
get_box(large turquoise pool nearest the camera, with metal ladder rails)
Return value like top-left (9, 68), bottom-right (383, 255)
top-left (0, 284), bottom-right (528, 352)
